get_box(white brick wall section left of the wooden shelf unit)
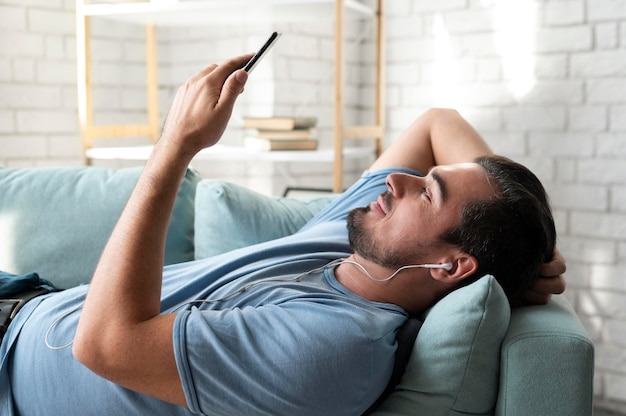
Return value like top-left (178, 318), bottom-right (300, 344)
top-left (0, 0), bottom-right (82, 166)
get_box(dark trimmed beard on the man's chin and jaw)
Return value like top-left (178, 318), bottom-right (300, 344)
top-left (347, 206), bottom-right (425, 269)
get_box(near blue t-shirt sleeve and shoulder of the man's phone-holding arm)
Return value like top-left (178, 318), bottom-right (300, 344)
top-left (174, 302), bottom-right (395, 415)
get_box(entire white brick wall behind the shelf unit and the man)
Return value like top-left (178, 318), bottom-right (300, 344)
top-left (0, 0), bottom-right (626, 414)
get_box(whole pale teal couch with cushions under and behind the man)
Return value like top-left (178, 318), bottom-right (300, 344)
top-left (0, 167), bottom-right (594, 416)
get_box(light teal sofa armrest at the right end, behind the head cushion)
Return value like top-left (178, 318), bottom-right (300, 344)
top-left (496, 295), bottom-right (594, 416)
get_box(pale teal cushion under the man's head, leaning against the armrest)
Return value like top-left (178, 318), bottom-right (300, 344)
top-left (374, 276), bottom-right (510, 416)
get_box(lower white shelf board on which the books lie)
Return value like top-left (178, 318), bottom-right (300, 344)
top-left (85, 145), bottom-right (374, 163)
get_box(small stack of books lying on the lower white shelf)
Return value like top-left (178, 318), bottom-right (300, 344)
top-left (243, 117), bottom-right (317, 150)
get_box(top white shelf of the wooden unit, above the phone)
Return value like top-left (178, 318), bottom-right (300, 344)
top-left (77, 0), bottom-right (376, 26)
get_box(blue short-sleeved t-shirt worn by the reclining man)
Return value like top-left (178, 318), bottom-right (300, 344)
top-left (0, 170), bottom-right (414, 416)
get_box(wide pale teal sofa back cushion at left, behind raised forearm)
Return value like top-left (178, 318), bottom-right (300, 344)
top-left (0, 167), bottom-right (200, 288)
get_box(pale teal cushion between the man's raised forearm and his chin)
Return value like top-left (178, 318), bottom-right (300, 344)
top-left (195, 179), bottom-right (333, 259)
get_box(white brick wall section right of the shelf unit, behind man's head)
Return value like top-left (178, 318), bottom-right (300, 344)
top-left (380, 0), bottom-right (626, 414)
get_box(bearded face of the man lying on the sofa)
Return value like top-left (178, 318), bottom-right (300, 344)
top-left (348, 163), bottom-right (494, 268)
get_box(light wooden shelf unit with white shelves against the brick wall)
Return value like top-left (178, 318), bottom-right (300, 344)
top-left (76, 0), bottom-right (385, 192)
